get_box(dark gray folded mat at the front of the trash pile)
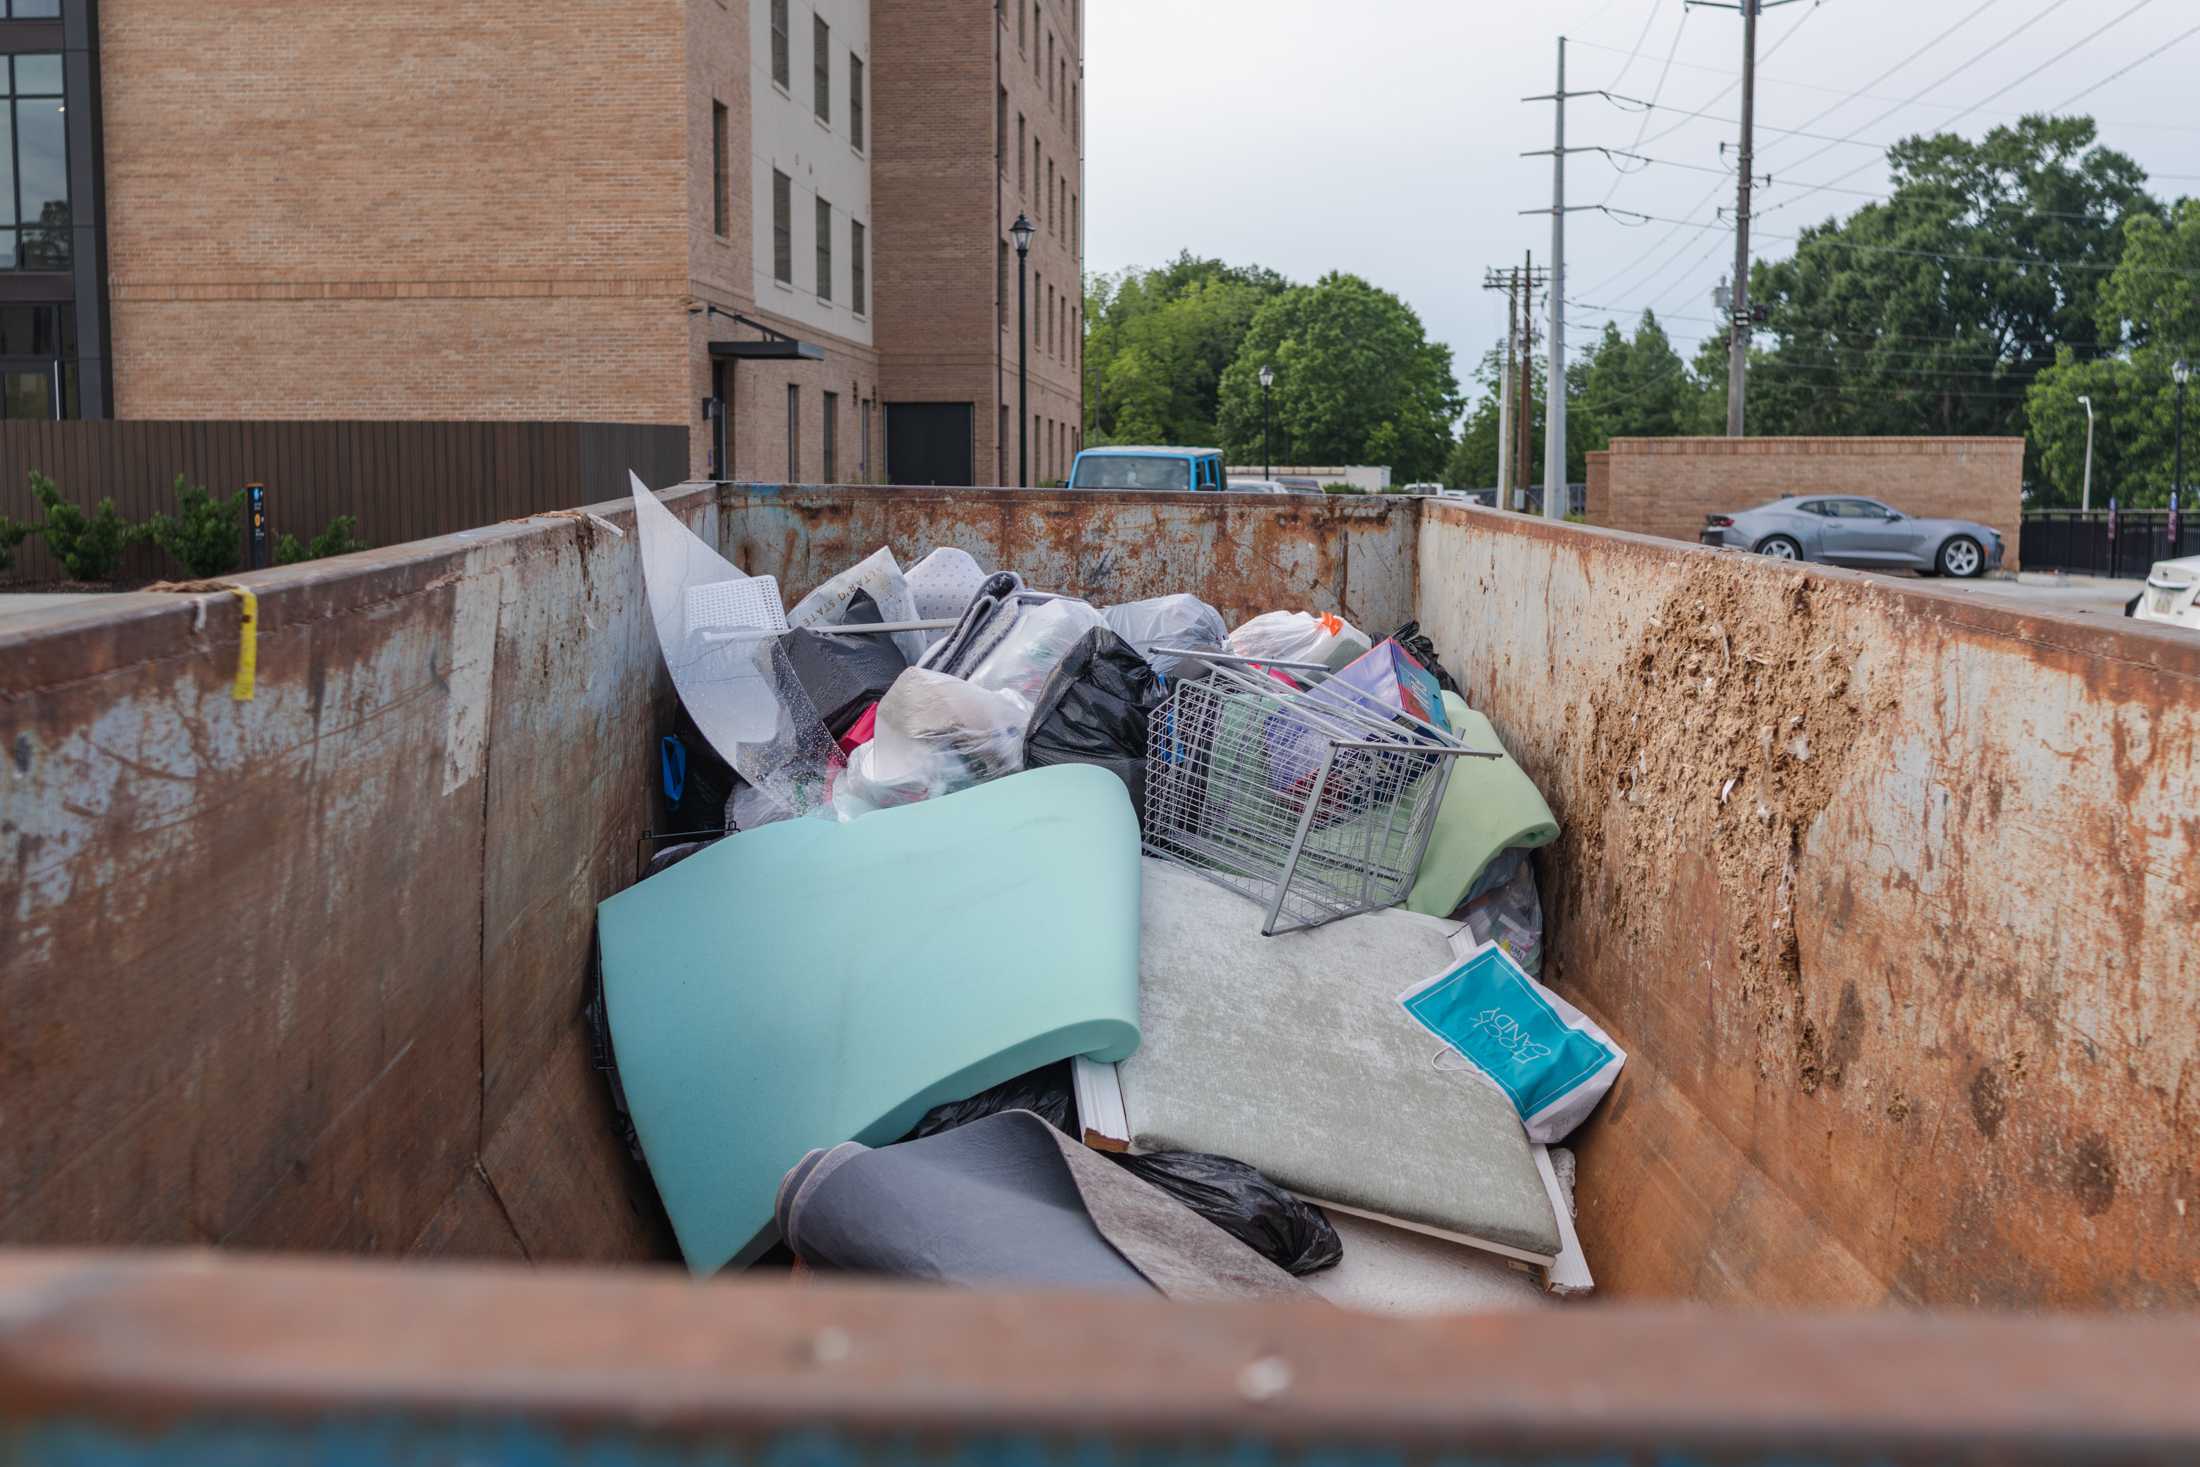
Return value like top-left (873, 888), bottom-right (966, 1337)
top-left (779, 1111), bottom-right (1313, 1300)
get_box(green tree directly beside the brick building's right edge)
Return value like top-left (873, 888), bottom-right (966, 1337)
top-left (1085, 253), bottom-right (1285, 446)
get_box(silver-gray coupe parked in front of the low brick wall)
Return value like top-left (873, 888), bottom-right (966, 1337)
top-left (1698, 495), bottom-right (2004, 576)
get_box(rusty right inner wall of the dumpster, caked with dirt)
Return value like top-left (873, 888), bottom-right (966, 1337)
top-left (1419, 506), bottom-right (2200, 1306)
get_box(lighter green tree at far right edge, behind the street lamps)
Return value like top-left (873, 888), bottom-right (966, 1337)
top-left (2024, 198), bottom-right (2200, 508)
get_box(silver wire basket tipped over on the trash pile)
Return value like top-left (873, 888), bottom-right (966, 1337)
top-left (1144, 651), bottom-right (1496, 937)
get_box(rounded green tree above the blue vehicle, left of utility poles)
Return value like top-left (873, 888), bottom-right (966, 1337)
top-left (1217, 273), bottom-right (1461, 484)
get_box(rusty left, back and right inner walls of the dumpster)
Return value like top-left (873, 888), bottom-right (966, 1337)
top-left (0, 488), bottom-right (2200, 1304)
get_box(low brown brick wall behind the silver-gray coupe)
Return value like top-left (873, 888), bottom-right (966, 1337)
top-left (1588, 438), bottom-right (2024, 567)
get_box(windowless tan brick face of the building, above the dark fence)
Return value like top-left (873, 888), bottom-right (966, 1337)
top-left (101, 0), bottom-right (689, 422)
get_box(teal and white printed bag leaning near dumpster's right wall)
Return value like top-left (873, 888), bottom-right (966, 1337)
top-left (1397, 944), bottom-right (1628, 1146)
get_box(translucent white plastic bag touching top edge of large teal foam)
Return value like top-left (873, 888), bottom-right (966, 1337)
top-left (832, 666), bottom-right (1032, 820)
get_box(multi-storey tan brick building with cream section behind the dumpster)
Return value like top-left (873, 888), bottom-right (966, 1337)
top-left (15, 0), bottom-right (1082, 484)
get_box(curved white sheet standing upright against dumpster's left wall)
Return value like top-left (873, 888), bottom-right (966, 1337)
top-left (629, 475), bottom-right (843, 816)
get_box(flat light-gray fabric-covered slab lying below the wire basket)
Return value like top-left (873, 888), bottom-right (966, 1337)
top-left (1118, 858), bottom-right (1560, 1258)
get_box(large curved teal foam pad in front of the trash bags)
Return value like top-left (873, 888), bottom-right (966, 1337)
top-left (596, 765), bottom-right (1140, 1273)
